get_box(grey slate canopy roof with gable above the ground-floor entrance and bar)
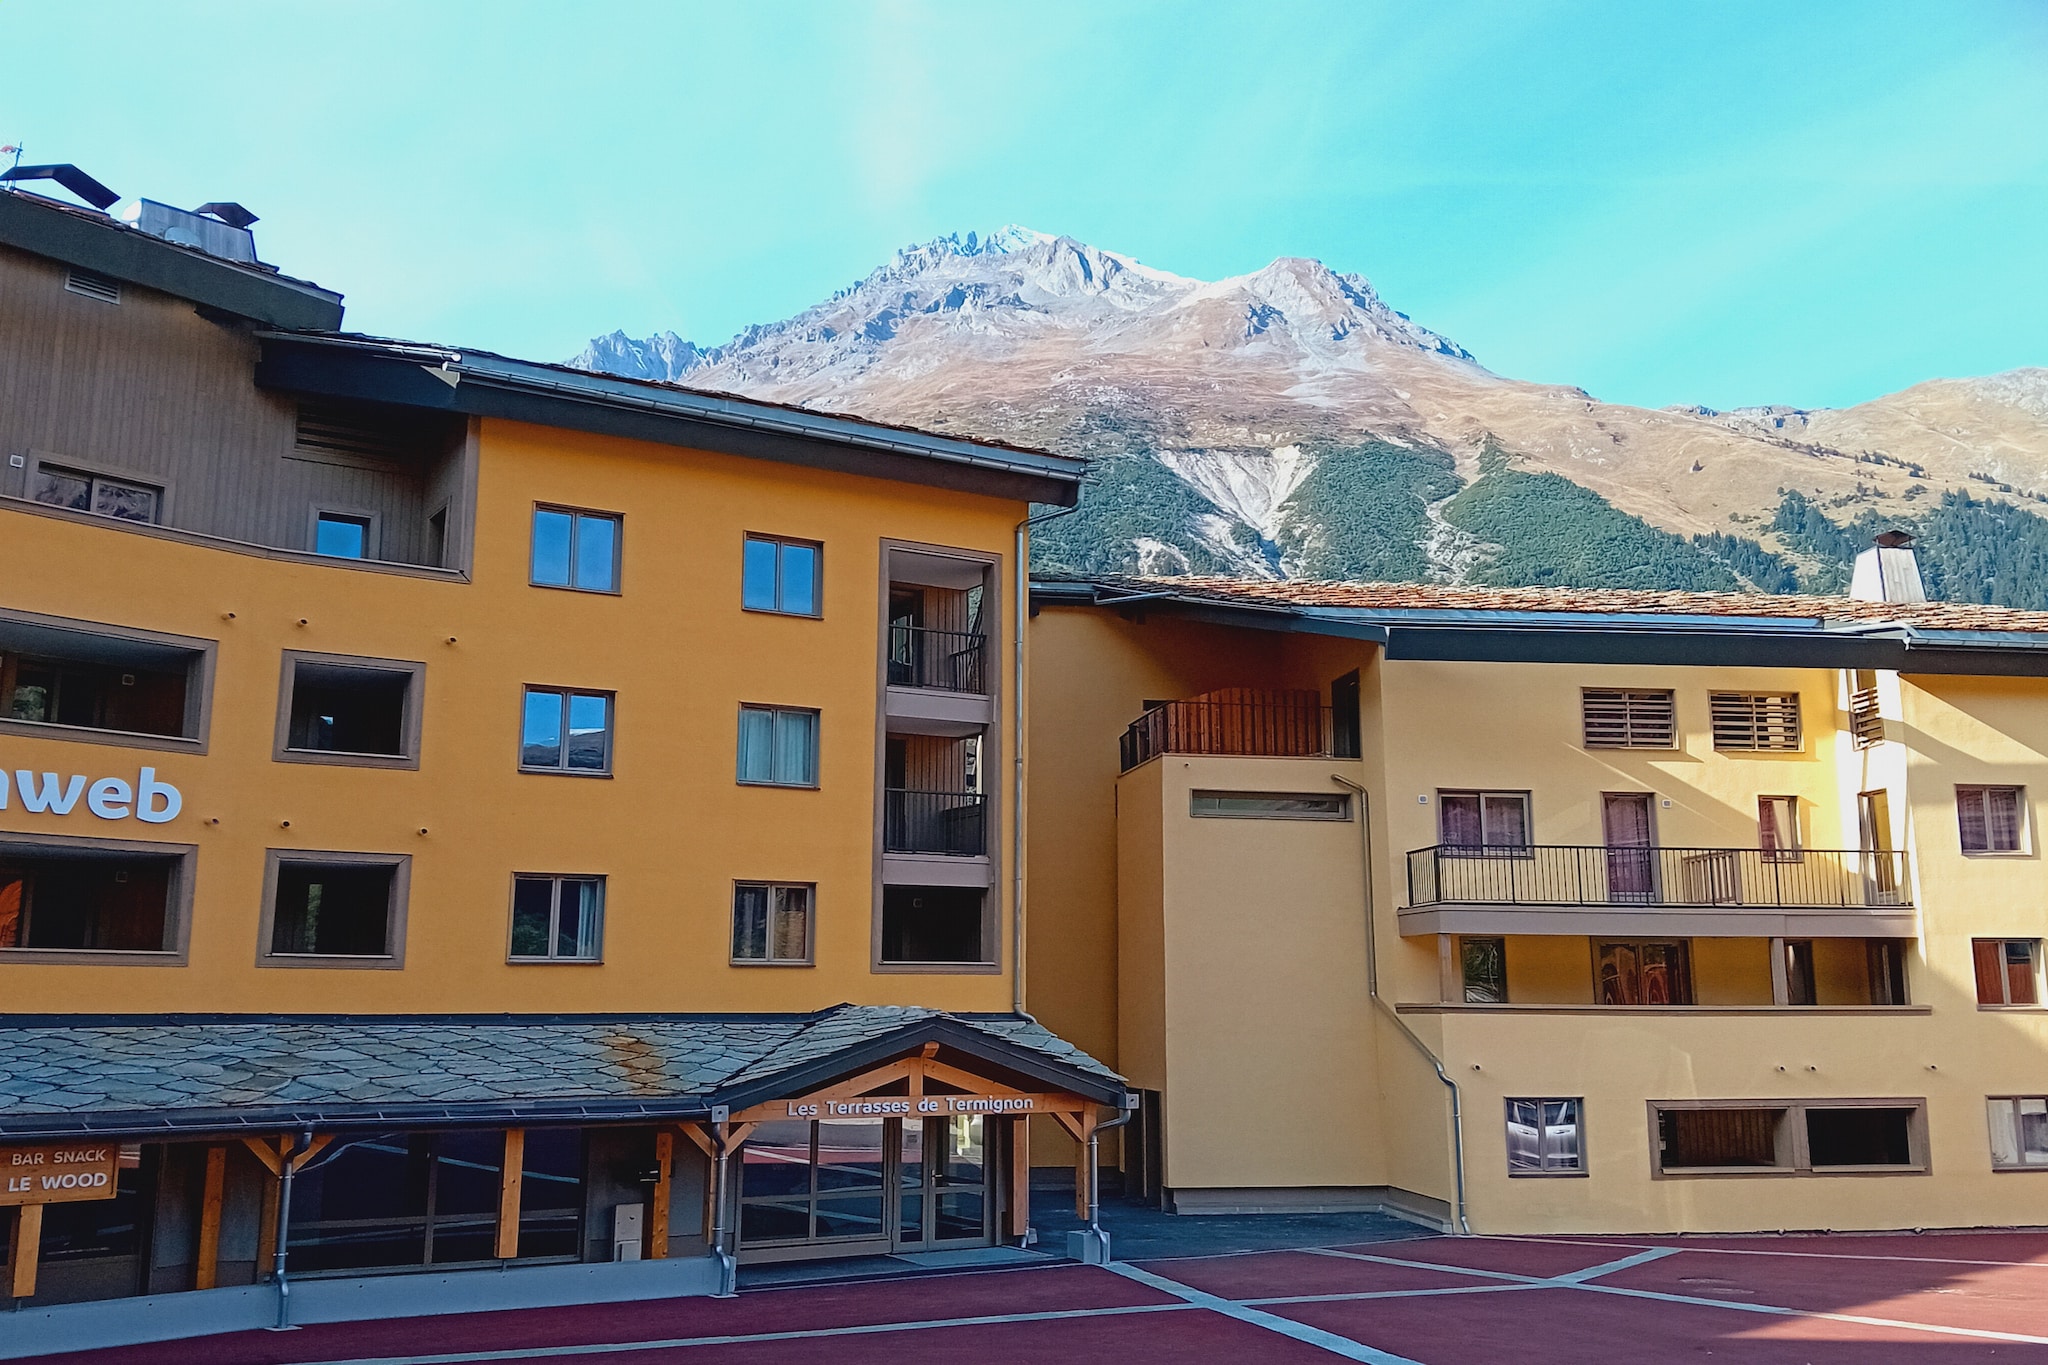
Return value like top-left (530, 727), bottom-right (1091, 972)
top-left (0, 1005), bottom-right (1124, 1138)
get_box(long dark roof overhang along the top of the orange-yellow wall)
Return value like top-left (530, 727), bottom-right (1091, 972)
top-left (256, 332), bottom-right (1083, 508)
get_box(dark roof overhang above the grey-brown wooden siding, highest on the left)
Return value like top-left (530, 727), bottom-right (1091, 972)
top-left (0, 192), bottom-right (342, 332)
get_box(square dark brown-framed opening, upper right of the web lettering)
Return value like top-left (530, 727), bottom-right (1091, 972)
top-left (270, 649), bottom-right (426, 767)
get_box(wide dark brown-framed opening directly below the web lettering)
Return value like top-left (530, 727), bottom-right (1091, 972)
top-left (0, 837), bottom-right (190, 956)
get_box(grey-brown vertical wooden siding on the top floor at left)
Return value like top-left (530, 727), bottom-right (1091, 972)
top-left (0, 248), bottom-right (473, 567)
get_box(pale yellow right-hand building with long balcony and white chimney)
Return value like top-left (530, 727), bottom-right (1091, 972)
top-left (1028, 564), bottom-right (2048, 1234)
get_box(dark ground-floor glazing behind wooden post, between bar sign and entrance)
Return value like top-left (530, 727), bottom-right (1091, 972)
top-left (287, 1128), bottom-right (584, 1271)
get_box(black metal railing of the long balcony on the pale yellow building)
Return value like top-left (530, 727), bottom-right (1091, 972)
top-left (1409, 843), bottom-right (1909, 909)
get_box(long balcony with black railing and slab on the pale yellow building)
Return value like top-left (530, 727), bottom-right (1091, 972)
top-left (1401, 845), bottom-right (1915, 937)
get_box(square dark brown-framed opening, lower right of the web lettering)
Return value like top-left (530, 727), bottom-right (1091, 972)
top-left (262, 849), bottom-right (412, 968)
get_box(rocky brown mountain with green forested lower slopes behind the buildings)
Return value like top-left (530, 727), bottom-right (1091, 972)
top-left (573, 227), bottom-right (2048, 610)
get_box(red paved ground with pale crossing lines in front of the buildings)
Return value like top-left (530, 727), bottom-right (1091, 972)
top-left (28, 1232), bottom-right (2048, 1365)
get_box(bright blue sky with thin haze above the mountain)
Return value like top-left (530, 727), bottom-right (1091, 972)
top-left (0, 0), bottom-right (2048, 407)
